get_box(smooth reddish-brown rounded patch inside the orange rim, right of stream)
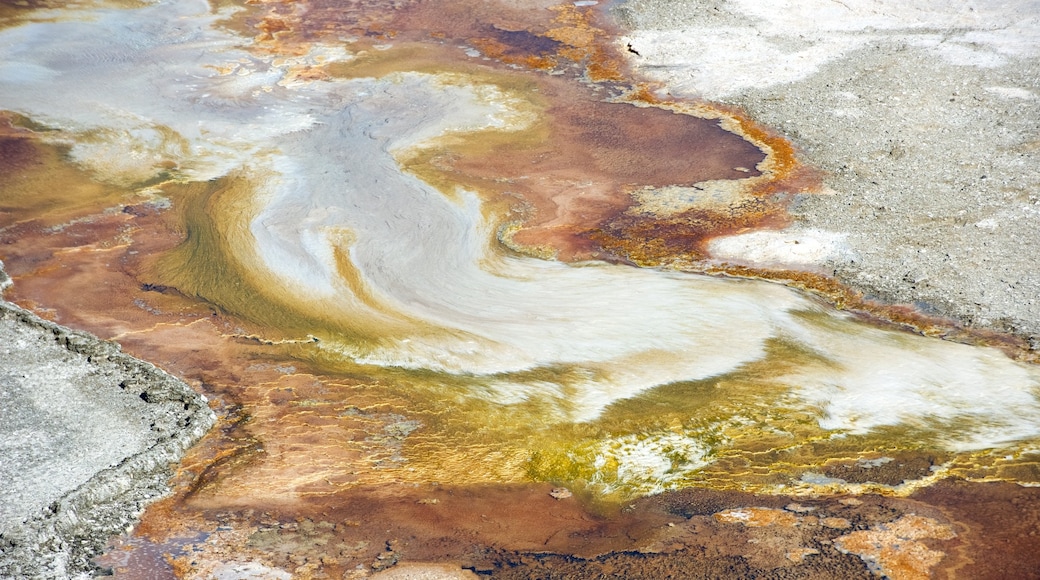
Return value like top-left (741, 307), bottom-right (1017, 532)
top-left (430, 82), bottom-right (763, 261)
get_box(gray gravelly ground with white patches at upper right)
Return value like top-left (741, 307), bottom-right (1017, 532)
top-left (615, 0), bottom-right (1040, 348)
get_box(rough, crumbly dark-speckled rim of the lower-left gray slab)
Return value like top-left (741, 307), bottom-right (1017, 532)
top-left (0, 264), bottom-right (216, 578)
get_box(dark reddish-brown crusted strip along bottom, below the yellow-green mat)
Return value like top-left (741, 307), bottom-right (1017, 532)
top-left (97, 482), bottom-right (1038, 579)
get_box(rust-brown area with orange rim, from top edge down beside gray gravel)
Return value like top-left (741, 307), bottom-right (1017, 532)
top-left (219, 0), bottom-right (818, 266)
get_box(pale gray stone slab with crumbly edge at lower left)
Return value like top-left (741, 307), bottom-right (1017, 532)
top-left (0, 270), bottom-right (215, 578)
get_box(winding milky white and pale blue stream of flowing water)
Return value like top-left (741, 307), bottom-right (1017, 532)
top-left (6, 1), bottom-right (1040, 489)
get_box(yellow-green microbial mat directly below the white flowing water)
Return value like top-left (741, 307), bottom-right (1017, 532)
top-left (278, 341), bottom-right (1040, 501)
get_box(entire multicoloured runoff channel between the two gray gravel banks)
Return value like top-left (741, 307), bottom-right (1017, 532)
top-left (0, 0), bottom-right (1040, 578)
